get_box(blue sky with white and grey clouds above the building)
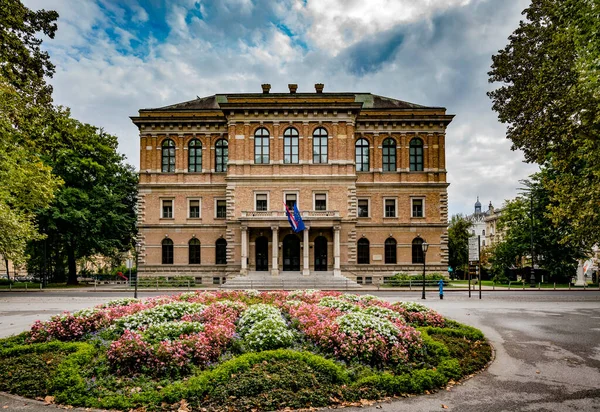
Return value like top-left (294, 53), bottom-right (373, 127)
top-left (23, 0), bottom-right (537, 214)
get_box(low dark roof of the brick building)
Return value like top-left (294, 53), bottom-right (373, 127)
top-left (143, 93), bottom-right (439, 111)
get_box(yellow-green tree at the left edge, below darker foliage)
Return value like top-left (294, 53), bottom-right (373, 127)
top-left (0, 77), bottom-right (61, 275)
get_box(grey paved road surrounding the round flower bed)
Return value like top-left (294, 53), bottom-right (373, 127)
top-left (0, 290), bottom-right (600, 412)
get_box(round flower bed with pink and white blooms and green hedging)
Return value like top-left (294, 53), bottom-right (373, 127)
top-left (0, 291), bottom-right (491, 410)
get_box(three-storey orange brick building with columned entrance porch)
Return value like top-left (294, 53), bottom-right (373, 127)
top-left (131, 84), bottom-right (453, 283)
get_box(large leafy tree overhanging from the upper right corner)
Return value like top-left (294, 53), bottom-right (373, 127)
top-left (488, 0), bottom-right (600, 249)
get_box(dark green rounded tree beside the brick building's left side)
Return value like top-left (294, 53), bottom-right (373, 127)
top-left (31, 108), bottom-right (137, 284)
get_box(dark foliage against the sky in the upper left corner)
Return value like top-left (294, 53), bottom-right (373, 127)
top-left (0, 0), bottom-right (58, 104)
